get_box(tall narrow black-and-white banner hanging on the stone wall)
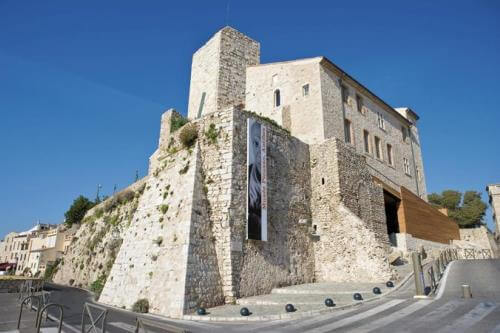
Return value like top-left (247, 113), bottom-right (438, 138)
top-left (247, 118), bottom-right (267, 241)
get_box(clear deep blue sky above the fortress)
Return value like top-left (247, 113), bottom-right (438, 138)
top-left (0, 0), bottom-right (500, 237)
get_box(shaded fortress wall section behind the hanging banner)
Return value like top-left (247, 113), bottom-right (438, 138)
top-left (230, 112), bottom-right (314, 297)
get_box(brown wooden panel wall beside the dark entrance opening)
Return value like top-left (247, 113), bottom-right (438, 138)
top-left (398, 186), bottom-right (460, 244)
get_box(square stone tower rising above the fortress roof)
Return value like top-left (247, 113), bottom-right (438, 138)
top-left (188, 27), bottom-right (260, 119)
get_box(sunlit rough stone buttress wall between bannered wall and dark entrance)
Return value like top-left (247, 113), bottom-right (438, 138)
top-left (311, 139), bottom-right (393, 281)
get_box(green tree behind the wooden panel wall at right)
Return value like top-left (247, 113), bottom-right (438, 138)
top-left (428, 190), bottom-right (488, 228)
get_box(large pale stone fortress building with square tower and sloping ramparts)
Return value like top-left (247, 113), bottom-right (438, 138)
top-left (55, 27), bottom-right (459, 317)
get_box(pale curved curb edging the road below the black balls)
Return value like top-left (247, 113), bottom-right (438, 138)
top-left (181, 272), bottom-right (414, 322)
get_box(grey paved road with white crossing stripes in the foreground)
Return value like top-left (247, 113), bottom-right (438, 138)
top-left (0, 260), bottom-right (500, 333)
